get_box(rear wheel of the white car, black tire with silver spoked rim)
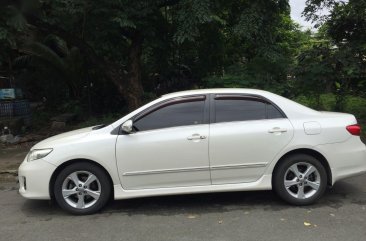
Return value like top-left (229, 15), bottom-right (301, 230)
top-left (272, 154), bottom-right (327, 206)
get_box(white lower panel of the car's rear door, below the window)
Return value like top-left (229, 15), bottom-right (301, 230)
top-left (209, 119), bottom-right (293, 184)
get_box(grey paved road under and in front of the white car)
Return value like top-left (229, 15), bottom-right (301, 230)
top-left (0, 175), bottom-right (366, 241)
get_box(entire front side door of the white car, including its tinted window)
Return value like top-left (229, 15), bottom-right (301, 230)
top-left (116, 95), bottom-right (211, 189)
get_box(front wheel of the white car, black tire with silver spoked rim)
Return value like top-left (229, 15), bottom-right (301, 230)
top-left (53, 162), bottom-right (112, 215)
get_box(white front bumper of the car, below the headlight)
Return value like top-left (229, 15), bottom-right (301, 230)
top-left (18, 159), bottom-right (57, 199)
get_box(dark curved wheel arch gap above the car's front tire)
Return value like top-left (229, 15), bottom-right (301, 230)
top-left (49, 158), bottom-right (114, 200)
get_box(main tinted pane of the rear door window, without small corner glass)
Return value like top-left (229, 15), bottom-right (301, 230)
top-left (215, 99), bottom-right (266, 122)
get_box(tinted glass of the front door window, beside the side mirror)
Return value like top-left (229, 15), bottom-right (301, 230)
top-left (134, 101), bottom-right (204, 131)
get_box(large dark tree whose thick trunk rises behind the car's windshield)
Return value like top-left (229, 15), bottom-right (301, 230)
top-left (2, 0), bottom-right (289, 109)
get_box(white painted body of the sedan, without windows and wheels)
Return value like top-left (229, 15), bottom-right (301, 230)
top-left (18, 89), bottom-right (366, 199)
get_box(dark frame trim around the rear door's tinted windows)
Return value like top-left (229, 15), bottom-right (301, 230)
top-left (210, 93), bottom-right (287, 124)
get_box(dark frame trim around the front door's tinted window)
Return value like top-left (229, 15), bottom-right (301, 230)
top-left (119, 94), bottom-right (210, 135)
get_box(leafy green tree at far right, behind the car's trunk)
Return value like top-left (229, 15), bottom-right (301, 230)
top-left (296, 0), bottom-right (366, 111)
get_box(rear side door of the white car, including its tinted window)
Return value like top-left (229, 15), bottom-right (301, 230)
top-left (209, 94), bottom-right (293, 184)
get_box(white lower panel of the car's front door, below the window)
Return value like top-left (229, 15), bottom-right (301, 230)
top-left (116, 124), bottom-right (211, 189)
